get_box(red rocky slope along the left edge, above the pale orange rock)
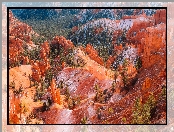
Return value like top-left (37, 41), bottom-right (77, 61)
top-left (9, 11), bottom-right (38, 65)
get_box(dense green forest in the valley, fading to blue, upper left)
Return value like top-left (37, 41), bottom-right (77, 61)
top-left (24, 14), bottom-right (73, 40)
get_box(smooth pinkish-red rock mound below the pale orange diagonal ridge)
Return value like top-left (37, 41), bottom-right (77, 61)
top-left (57, 68), bottom-right (112, 99)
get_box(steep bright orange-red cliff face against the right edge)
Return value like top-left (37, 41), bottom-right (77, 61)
top-left (141, 24), bottom-right (166, 68)
